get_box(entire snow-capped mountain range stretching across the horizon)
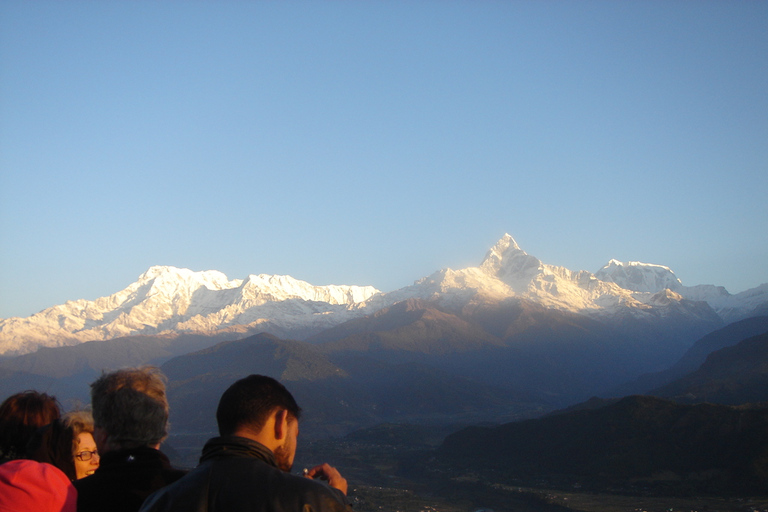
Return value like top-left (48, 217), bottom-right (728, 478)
top-left (0, 234), bottom-right (768, 355)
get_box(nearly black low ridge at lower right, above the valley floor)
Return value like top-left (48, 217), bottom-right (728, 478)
top-left (438, 396), bottom-right (768, 495)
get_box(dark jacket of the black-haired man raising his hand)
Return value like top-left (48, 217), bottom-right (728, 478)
top-left (141, 436), bottom-right (351, 512)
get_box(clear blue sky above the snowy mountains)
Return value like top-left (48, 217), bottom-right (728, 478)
top-left (0, 0), bottom-right (768, 318)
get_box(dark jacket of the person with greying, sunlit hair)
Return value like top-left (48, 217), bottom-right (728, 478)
top-left (72, 447), bottom-right (186, 512)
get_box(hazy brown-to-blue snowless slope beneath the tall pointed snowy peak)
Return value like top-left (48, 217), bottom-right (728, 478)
top-left (307, 297), bottom-right (713, 406)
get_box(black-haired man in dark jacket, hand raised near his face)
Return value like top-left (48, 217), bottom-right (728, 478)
top-left (141, 375), bottom-right (351, 512)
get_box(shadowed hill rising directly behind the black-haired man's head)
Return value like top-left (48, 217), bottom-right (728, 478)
top-left (162, 334), bottom-right (536, 438)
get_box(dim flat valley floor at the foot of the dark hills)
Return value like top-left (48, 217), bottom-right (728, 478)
top-left (166, 431), bottom-right (768, 512)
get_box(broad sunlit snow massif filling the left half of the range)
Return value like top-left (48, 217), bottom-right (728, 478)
top-left (0, 266), bottom-right (378, 355)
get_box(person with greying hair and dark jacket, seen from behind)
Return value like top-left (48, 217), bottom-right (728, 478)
top-left (75, 366), bottom-right (186, 512)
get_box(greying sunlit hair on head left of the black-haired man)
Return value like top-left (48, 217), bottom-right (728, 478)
top-left (91, 366), bottom-right (169, 448)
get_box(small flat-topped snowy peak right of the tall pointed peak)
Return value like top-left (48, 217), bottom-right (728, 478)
top-left (595, 259), bottom-right (683, 293)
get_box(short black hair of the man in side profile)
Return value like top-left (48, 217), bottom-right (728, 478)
top-left (216, 375), bottom-right (301, 436)
